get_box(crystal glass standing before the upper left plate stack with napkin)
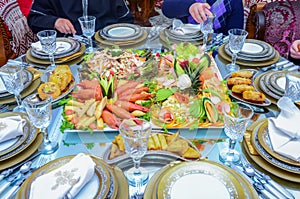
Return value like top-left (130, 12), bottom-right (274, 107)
top-left (37, 30), bottom-right (57, 71)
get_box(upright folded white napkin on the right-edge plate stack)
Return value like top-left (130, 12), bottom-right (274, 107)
top-left (268, 97), bottom-right (300, 162)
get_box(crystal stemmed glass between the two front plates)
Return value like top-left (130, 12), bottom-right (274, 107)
top-left (119, 118), bottom-right (152, 190)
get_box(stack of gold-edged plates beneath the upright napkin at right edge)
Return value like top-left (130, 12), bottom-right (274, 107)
top-left (244, 119), bottom-right (300, 183)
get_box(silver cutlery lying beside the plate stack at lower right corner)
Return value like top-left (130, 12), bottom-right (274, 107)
top-left (241, 156), bottom-right (295, 199)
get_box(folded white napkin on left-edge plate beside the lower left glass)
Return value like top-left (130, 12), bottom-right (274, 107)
top-left (0, 116), bottom-right (26, 143)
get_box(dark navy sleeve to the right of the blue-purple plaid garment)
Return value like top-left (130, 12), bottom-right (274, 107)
top-left (217, 0), bottom-right (244, 35)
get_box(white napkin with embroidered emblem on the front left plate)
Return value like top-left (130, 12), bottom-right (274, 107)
top-left (30, 153), bottom-right (95, 199)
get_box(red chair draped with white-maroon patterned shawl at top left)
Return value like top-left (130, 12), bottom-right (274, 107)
top-left (0, 0), bottom-right (37, 66)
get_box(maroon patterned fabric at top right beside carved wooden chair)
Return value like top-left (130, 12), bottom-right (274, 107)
top-left (263, 1), bottom-right (300, 58)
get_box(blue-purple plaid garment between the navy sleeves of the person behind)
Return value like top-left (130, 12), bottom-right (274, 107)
top-left (188, 0), bottom-right (232, 30)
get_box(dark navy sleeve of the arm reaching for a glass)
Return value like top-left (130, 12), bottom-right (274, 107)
top-left (161, 0), bottom-right (196, 18)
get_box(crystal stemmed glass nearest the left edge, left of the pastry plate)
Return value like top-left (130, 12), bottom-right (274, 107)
top-left (0, 65), bottom-right (25, 112)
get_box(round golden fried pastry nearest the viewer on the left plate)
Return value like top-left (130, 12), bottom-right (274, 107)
top-left (38, 82), bottom-right (61, 100)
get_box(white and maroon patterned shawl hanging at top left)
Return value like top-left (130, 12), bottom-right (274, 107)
top-left (0, 0), bottom-right (36, 56)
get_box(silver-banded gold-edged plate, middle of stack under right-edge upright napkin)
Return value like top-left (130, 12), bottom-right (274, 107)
top-left (251, 119), bottom-right (300, 175)
